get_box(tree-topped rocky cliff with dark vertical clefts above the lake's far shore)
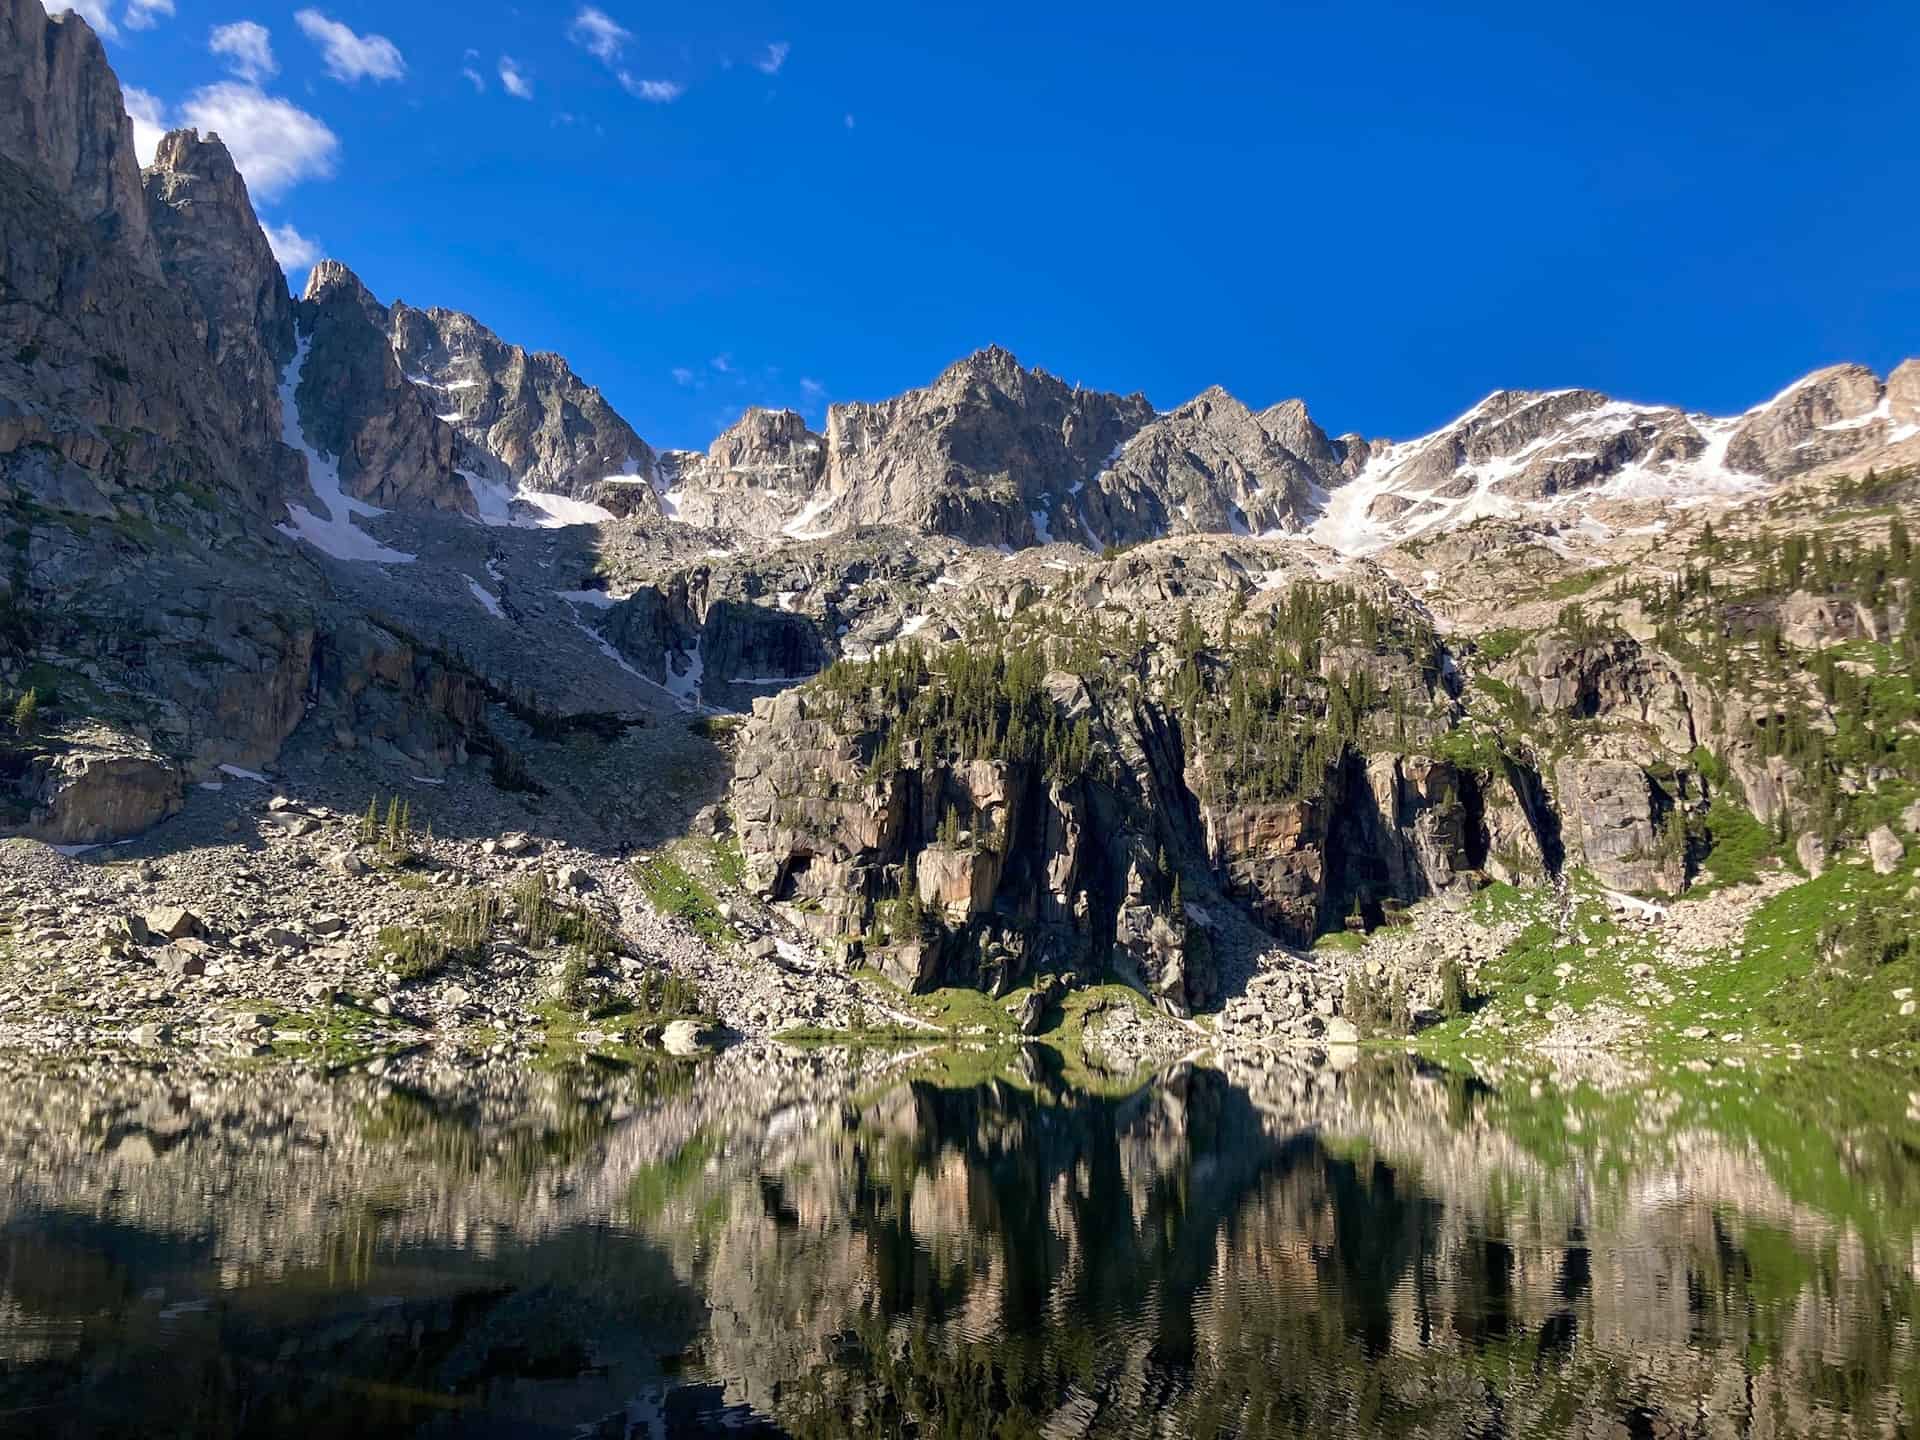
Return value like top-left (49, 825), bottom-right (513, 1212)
top-left (732, 541), bottom-right (1605, 1012)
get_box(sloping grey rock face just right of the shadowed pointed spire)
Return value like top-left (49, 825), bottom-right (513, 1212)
top-left (386, 301), bottom-right (655, 515)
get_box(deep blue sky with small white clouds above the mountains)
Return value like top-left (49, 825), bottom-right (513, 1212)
top-left (71, 0), bottom-right (1920, 445)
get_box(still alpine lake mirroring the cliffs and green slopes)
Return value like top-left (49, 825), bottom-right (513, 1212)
top-left (0, 1050), bottom-right (1920, 1436)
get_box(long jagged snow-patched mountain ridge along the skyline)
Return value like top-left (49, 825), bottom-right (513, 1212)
top-left (278, 261), bottom-right (1920, 563)
